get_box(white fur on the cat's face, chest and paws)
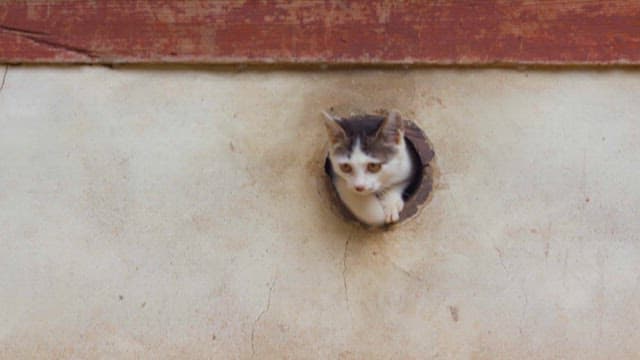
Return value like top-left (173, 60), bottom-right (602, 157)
top-left (331, 139), bottom-right (413, 226)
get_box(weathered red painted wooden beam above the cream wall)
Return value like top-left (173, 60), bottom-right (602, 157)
top-left (0, 0), bottom-right (640, 65)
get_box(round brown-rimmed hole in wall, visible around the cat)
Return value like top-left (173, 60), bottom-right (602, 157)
top-left (324, 117), bottom-right (435, 229)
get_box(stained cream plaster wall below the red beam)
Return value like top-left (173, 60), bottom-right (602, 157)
top-left (0, 66), bottom-right (640, 359)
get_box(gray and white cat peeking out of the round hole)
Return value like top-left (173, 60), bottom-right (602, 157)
top-left (323, 111), bottom-right (417, 226)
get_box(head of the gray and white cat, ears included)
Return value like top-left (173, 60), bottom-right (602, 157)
top-left (323, 111), bottom-right (405, 195)
